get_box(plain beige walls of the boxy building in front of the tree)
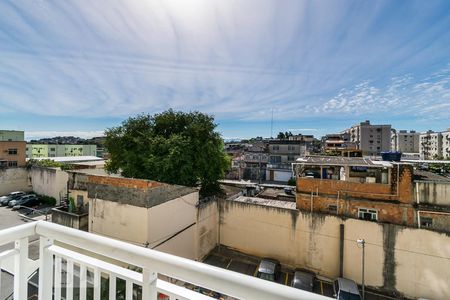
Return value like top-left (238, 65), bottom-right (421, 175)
top-left (89, 192), bottom-right (200, 259)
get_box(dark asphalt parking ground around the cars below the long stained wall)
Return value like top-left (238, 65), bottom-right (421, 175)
top-left (203, 246), bottom-right (399, 300)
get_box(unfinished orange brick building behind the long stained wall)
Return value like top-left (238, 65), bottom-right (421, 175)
top-left (295, 156), bottom-right (416, 226)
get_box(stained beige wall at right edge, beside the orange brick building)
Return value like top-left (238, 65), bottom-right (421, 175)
top-left (414, 181), bottom-right (450, 206)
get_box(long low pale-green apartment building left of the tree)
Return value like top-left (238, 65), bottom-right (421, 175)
top-left (26, 144), bottom-right (97, 158)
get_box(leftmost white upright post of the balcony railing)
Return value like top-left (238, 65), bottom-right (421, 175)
top-left (14, 238), bottom-right (28, 300)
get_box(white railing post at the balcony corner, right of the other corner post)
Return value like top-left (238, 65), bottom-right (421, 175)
top-left (38, 237), bottom-right (53, 300)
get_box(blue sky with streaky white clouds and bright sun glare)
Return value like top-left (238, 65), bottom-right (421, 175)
top-left (0, 0), bottom-right (450, 138)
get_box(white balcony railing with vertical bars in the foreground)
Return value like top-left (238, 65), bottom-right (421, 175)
top-left (0, 221), bottom-right (328, 300)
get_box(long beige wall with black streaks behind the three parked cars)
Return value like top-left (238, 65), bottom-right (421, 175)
top-left (220, 201), bottom-right (450, 299)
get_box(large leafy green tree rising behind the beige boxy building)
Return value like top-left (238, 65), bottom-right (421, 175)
top-left (105, 110), bottom-right (229, 196)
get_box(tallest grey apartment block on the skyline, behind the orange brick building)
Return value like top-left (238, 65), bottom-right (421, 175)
top-left (344, 120), bottom-right (391, 155)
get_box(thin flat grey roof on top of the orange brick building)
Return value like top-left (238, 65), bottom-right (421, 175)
top-left (294, 156), bottom-right (393, 168)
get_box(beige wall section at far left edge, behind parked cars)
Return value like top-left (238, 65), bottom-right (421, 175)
top-left (0, 168), bottom-right (31, 196)
